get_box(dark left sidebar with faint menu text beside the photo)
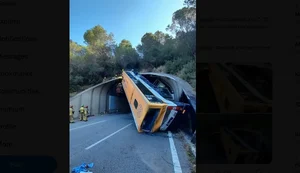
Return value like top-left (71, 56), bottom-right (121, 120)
top-left (0, 0), bottom-right (69, 173)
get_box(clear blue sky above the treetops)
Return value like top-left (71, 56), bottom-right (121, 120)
top-left (70, 0), bottom-right (183, 47)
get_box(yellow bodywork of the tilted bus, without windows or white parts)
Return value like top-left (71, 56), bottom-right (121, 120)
top-left (122, 71), bottom-right (167, 132)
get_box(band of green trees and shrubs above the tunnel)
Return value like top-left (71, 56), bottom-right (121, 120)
top-left (69, 0), bottom-right (196, 93)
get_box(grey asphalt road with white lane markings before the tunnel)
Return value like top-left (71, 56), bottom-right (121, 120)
top-left (70, 114), bottom-right (190, 173)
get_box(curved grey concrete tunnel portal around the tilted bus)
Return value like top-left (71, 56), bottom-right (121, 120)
top-left (70, 73), bottom-right (196, 134)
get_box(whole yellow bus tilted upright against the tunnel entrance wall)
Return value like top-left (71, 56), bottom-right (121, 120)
top-left (122, 71), bottom-right (188, 133)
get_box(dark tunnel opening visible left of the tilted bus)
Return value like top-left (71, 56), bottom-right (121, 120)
top-left (106, 80), bottom-right (131, 114)
